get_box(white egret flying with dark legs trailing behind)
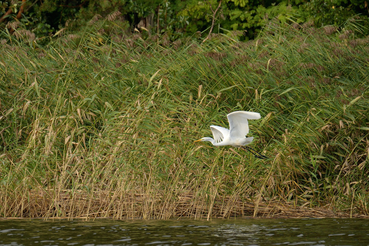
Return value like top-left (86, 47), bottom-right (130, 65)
top-left (195, 111), bottom-right (268, 159)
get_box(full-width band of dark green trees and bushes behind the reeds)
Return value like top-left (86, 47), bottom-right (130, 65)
top-left (0, 0), bottom-right (369, 43)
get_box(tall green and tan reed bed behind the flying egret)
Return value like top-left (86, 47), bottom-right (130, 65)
top-left (0, 19), bottom-right (369, 219)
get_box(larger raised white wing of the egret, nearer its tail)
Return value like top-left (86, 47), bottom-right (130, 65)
top-left (227, 111), bottom-right (261, 139)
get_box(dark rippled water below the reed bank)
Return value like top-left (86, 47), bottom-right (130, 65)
top-left (0, 219), bottom-right (369, 246)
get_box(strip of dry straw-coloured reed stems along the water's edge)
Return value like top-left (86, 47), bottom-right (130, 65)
top-left (6, 188), bottom-right (369, 220)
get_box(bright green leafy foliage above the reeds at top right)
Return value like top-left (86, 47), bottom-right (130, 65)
top-left (179, 0), bottom-right (369, 38)
